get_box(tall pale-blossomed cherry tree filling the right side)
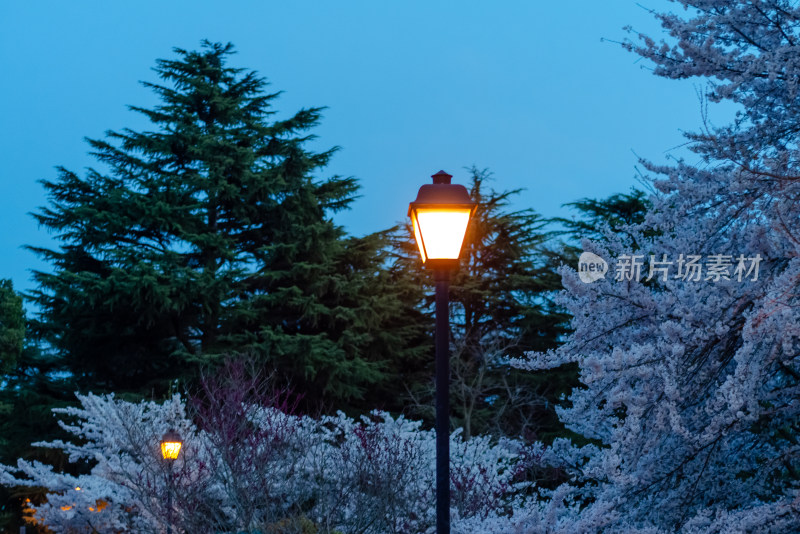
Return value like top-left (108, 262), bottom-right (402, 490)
top-left (510, 0), bottom-right (800, 532)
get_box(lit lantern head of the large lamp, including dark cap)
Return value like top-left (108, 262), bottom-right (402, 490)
top-left (408, 171), bottom-right (476, 270)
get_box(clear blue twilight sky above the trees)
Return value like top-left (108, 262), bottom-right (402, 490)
top-left (0, 0), bottom-right (732, 296)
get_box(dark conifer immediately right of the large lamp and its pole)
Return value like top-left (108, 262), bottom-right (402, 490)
top-left (451, 168), bottom-right (577, 441)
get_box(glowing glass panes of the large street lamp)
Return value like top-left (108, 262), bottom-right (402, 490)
top-left (415, 208), bottom-right (472, 261)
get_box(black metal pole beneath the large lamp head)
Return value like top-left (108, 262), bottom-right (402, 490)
top-left (436, 269), bottom-right (450, 534)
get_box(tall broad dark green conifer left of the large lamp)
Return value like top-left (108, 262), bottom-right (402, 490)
top-left (27, 42), bottom-right (413, 408)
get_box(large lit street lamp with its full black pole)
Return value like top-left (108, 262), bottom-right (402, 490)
top-left (408, 171), bottom-right (476, 534)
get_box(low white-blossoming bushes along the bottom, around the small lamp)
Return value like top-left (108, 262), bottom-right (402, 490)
top-left (0, 383), bottom-right (527, 534)
